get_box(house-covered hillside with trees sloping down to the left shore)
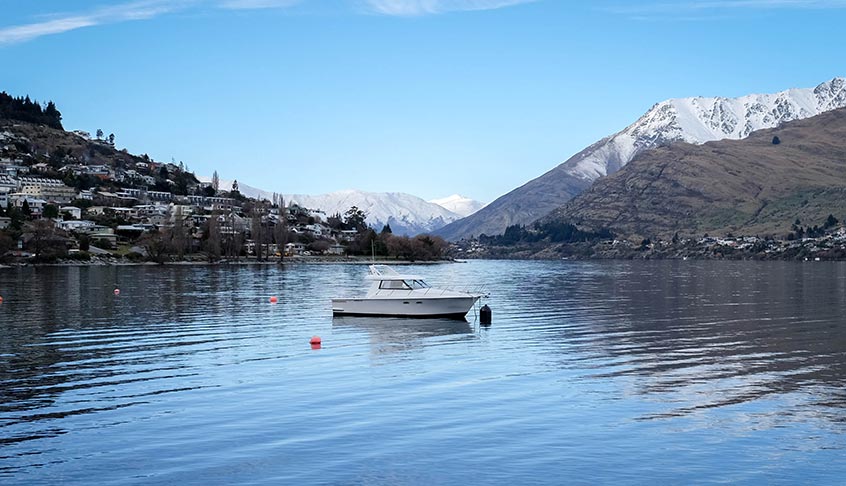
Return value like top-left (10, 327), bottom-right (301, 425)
top-left (0, 117), bottom-right (447, 264)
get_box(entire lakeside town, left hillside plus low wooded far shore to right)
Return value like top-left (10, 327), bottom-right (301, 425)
top-left (0, 93), bottom-right (846, 264)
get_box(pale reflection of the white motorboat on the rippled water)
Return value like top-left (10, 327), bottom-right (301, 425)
top-left (332, 316), bottom-right (475, 354)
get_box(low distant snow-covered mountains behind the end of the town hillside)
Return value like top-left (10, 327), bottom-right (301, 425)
top-left (197, 176), bottom-right (461, 235)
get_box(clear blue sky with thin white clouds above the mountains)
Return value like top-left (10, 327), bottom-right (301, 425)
top-left (0, 0), bottom-right (846, 202)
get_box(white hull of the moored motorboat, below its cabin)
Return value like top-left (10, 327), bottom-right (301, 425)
top-left (332, 296), bottom-right (479, 318)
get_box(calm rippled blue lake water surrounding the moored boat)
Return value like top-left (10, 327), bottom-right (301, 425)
top-left (0, 261), bottom-right (846, 485)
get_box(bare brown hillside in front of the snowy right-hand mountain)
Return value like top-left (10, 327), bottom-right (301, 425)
top-left (540, 108), bottom-right (846, 239)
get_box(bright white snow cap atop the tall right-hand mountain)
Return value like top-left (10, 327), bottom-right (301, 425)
top-left (565, 78), bottom-right (846, 180)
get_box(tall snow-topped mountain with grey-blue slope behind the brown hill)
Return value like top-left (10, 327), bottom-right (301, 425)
top-left (436, 78), bottom-right (846, 240)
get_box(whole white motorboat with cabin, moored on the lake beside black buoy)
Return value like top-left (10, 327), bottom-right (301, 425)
top-left (332, 265), bottom-right (485, 318)
